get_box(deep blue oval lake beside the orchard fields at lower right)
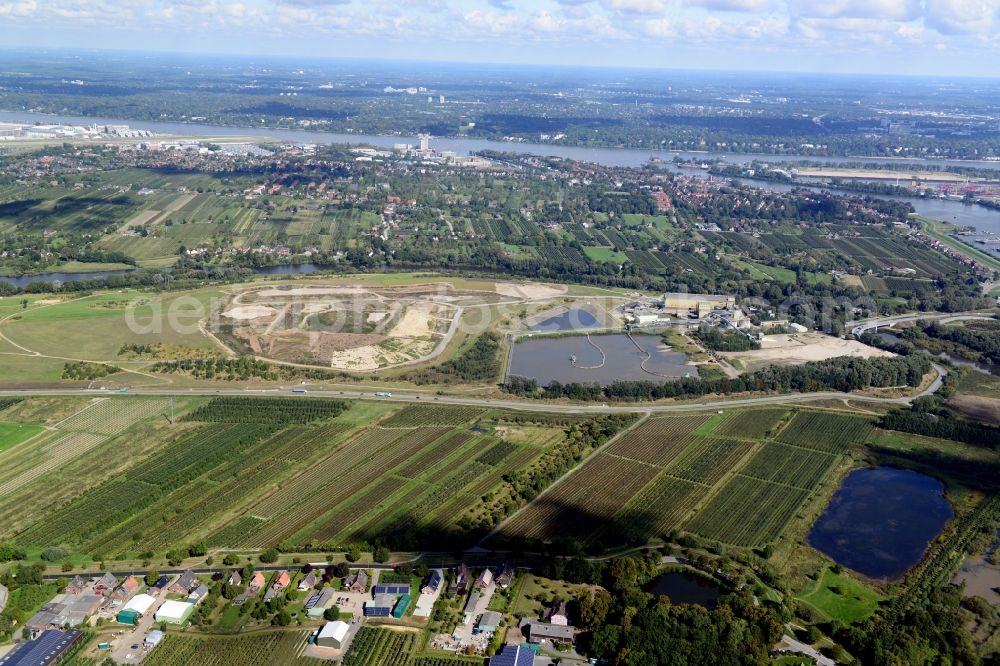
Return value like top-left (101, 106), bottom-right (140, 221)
top-left (809, 467), bottom-right (955, 580)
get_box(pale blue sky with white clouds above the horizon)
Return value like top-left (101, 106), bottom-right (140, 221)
top-left (0, 0), bottom-right (1000, 76)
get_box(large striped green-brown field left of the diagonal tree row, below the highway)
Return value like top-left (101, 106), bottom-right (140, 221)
top-left (0, 396), bottom-right (580, 558)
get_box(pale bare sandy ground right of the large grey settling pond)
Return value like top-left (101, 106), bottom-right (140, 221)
top-left (722, 332), bottom-right (893, 371)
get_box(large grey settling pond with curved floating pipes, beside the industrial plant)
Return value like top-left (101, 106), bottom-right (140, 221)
top-left (508, 333), bottom-right (697, 386)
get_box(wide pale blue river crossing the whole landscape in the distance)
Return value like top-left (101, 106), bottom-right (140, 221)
top-left (0, 111), bottom-right (1000, 234)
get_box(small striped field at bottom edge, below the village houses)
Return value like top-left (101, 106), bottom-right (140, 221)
top-left (143, 630), bottom-right (325, 666)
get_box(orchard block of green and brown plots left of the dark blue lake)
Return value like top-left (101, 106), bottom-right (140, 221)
top-left (499, 409), bottom-right (871, 546)
